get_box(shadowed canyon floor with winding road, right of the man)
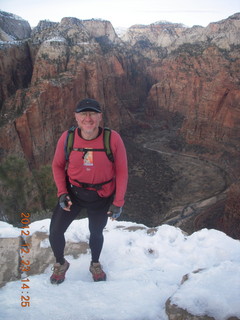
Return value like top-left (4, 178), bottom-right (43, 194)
top-left (122, 115), bottom-right (230, 233)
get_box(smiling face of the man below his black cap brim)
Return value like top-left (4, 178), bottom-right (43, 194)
top-left (75, 111), bottom-right (102, 134)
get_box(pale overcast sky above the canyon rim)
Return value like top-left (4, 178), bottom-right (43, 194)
top-left (0, 0), bottom-right (240, 28)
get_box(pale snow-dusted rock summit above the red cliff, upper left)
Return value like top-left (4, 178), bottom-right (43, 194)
top-left (32, 18), bottom-right (101, 85)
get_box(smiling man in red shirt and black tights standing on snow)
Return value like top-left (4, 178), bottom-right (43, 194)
top-left (49, 99), bottom-right (128, 284)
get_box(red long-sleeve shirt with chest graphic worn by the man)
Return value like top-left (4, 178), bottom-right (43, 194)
top-left (52, 130), bottom-right (128, 207)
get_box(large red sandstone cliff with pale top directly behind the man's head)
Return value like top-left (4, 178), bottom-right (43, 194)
top-left (0, 18), bottom-right (145, 167)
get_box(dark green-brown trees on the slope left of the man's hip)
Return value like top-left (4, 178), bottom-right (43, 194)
top-left (0, 156), bottom-right (56, 226)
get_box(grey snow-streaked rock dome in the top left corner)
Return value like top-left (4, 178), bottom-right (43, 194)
top-left (0, 11), bottom-right (31, 41)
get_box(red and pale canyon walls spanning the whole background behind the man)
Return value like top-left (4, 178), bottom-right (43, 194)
top-left (0, 12), bottom-right (240, 238)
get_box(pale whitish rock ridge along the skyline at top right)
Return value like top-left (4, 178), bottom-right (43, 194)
top-left (121, 13), bottom-right (240, 53)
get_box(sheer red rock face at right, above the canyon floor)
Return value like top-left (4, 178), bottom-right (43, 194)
top-left (148, 46), bottom-right (240, 153)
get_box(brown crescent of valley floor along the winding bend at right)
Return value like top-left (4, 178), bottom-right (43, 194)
top-left (144, 141), bottom-right (229, 226)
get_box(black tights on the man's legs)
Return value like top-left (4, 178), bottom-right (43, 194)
top-left (49, 186), bottom-right (112, 263)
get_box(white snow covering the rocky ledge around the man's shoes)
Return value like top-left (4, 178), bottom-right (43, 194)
top-left (0, 219), bottom-right (240, 320)
